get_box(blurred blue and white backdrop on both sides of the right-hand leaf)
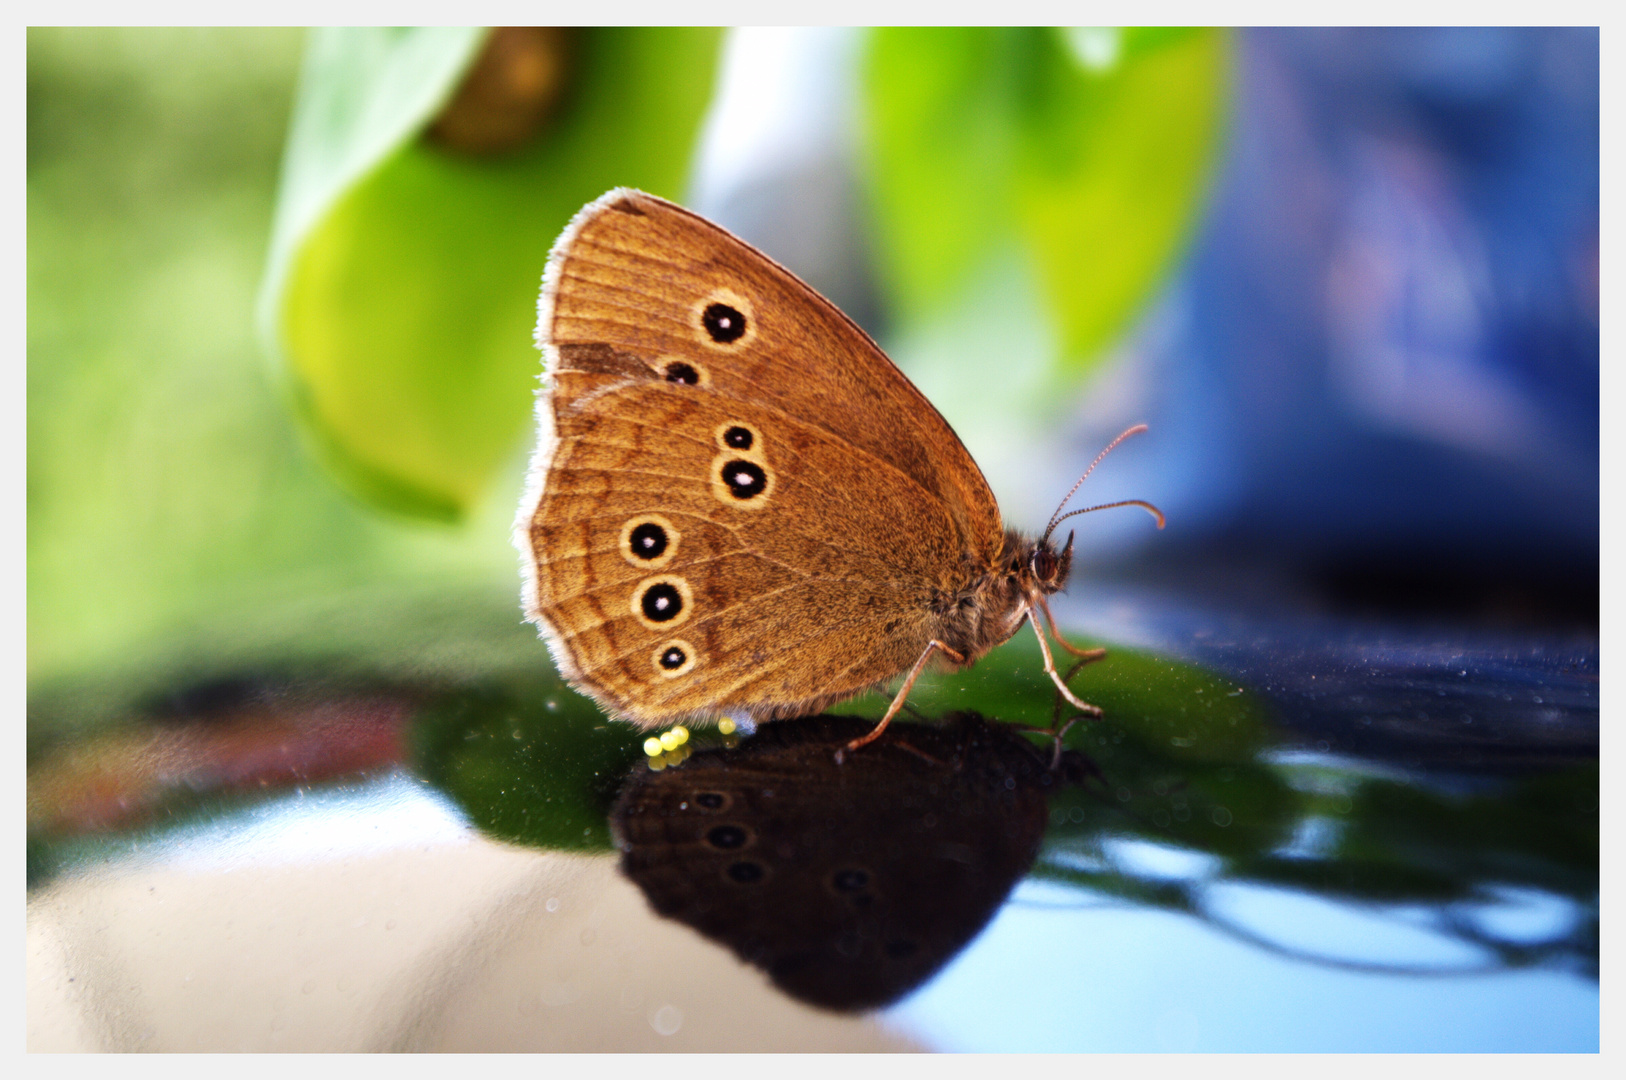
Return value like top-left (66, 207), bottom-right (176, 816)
top-left (696, 28), bottom-right (1598, 626)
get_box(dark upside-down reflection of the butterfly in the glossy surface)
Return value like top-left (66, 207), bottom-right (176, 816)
top-left (611, 714), bottom-right (1086, 1010)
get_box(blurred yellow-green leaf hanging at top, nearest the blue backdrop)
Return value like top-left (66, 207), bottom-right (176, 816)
top-left (863, 28), bottom-right (1228, 377)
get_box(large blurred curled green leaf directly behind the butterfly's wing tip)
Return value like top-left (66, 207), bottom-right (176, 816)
top-left (260, 28), bottom-right (719, 520)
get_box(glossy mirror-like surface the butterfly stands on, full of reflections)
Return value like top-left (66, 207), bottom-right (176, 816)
top-left (29, 586), bottom-right (1598, 1051)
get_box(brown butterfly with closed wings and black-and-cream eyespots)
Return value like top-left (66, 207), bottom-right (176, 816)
top-left (514, 189), bottom-right (1163, 750)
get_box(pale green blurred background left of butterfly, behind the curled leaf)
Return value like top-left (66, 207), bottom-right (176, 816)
top-left (28, 29), bottom-right (715, 715)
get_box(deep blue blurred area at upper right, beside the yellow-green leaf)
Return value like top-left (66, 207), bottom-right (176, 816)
top-left (1140, 29), bottom-right (1598, 615)
